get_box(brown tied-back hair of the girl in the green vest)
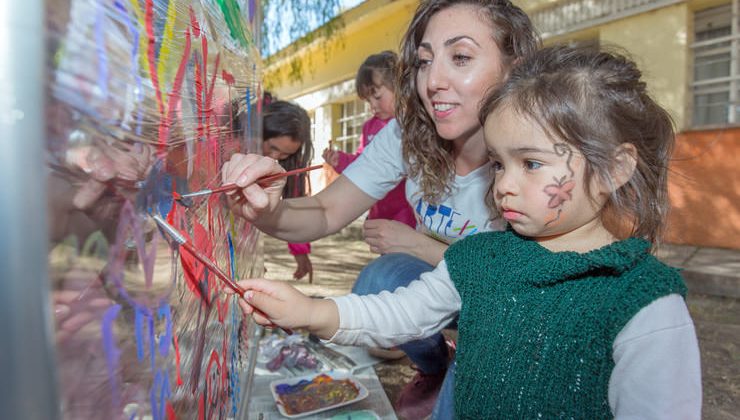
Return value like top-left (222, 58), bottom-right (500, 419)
top-left (480, 46), bottom-right (674, 244)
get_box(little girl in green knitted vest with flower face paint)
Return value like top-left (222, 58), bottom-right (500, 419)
top-left (230, 47), bottom-right (701, 419)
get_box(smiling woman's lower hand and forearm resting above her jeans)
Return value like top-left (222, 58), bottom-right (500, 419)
top-left (363, 219), bottom-right (447, 265)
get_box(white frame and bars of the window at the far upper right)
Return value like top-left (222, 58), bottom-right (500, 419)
top-left (690, 0), bottom-right (740, 128)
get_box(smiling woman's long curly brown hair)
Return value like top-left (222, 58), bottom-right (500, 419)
top-left (396, 0), bottom-right (539, 203)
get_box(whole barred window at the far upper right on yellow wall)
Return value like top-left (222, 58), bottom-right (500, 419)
top-left (691, 0), bottom-right (740, 126)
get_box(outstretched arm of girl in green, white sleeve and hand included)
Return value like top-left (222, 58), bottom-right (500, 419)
top-left (239, 261), bottom-right (460, 347)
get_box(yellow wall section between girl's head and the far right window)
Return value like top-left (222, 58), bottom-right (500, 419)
top-left (598, 4), bottom-right (691, 130)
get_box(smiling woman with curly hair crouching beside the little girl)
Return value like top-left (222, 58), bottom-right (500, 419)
top-left (222, 0), bottom-right (539, 418)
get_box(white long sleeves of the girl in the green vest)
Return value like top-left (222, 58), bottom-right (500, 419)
top-left (330, 261), bottom-right (701, 419)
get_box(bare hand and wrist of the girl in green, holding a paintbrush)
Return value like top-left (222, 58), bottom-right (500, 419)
top-left (230, 279), bottom-right (339, 338)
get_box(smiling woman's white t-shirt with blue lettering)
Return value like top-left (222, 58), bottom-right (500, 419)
top-left (343, 119), bottom-right (504, 244)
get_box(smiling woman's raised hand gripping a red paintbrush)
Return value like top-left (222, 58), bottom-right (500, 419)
top-left (221, 153), bottom-right (285, 221)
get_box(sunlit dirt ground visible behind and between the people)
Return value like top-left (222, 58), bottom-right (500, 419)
top-left (264, 222), bottom-right (740, 420)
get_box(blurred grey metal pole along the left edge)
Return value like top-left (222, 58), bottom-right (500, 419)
top-left (0, 0), bottom-right (60, 420)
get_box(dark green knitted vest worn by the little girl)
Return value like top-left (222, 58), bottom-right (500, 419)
top-left (445, 231), bottom-right (686, 419)
